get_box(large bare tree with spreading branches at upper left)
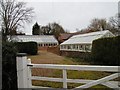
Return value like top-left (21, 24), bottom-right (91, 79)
top-left (0, 0), bottom-right (34, 40)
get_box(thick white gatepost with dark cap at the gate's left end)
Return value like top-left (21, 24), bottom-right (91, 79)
top-left (16, 53), bottom-right (28, 88)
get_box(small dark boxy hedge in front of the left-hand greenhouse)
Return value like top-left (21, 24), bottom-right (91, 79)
top-left (16, 42), bottom-right (38, 55)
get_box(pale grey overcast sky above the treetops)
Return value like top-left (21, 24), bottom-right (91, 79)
top-left (24, 2), bottom-right (118, 34)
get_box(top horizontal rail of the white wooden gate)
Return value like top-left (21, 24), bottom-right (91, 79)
top-left (27, 64), bottom-right (118, 72)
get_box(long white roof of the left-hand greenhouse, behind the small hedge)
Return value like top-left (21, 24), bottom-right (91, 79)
top-left (8, 35), bottom-right (58, 43)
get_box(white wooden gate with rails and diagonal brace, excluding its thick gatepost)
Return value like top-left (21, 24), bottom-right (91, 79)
top-left (28, 64), bottom-right (119, 90)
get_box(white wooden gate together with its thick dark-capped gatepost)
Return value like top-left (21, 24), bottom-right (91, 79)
top-left (17, 54), bottom-right (120, 90)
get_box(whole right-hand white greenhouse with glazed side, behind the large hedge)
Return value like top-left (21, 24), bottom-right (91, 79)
top-left (60, 30), bottom-right (114, 52)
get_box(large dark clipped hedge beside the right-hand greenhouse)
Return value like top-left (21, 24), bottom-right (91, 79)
top-left (91, 36), bottom-right (120, 65)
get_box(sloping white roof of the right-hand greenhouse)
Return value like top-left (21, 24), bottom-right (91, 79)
top-left (61, 30), bottom-right (113, 45)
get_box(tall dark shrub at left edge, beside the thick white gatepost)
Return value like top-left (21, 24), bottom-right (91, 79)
top-left (2, 42), bottom-right (17, 90)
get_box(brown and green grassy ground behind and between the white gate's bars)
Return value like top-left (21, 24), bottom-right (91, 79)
top-left (28, 51), bottom-right (113, 88)
